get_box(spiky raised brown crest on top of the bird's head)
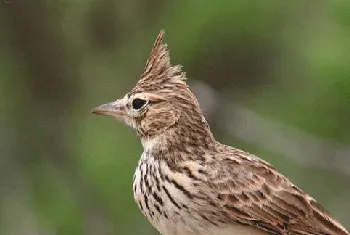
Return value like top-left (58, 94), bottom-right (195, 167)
top-left (135, 30), bottom-right (186, 90)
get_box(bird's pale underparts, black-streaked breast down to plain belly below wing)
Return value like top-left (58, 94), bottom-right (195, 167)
top-left (133, 153), bottom-right (268, 235)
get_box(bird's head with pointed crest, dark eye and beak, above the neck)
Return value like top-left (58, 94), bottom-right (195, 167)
top-left (92, 31), bottom-right (212, 150)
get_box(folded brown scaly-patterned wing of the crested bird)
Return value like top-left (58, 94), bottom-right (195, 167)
top-left (207, 150), bottom-right (349, 235)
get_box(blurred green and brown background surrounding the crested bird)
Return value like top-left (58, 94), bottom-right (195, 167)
top-left (0, 0), bottom-right (350, 235)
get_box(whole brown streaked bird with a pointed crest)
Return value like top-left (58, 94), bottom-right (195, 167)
top-left (92, 30), bottom-right (349, 235)
